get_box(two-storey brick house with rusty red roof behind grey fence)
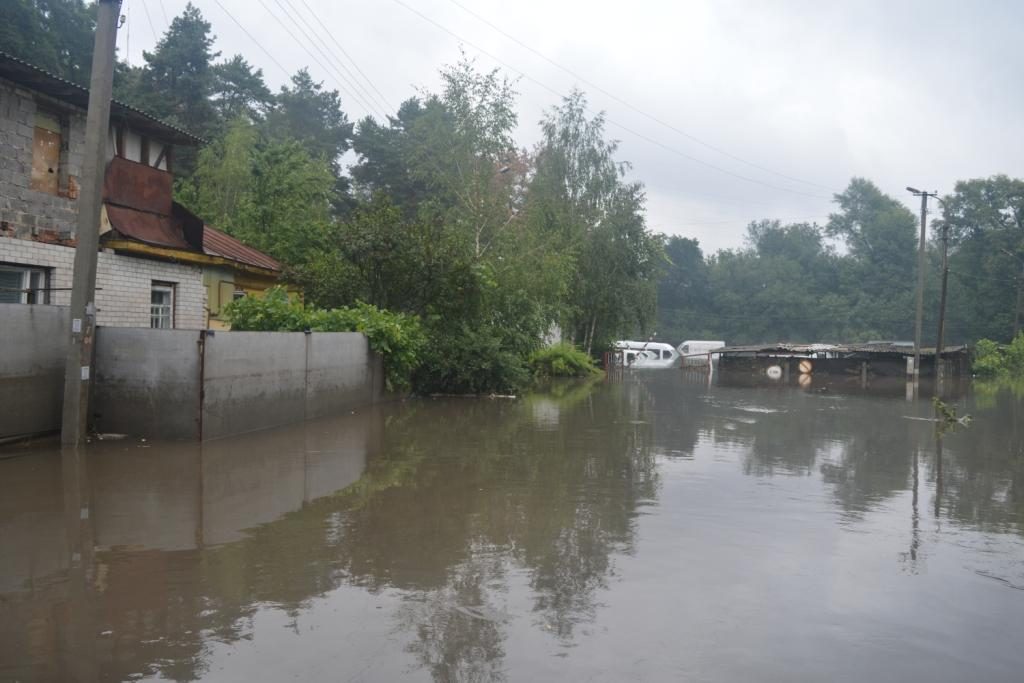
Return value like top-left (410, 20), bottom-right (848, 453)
top-left (0, 52), bottom-right (281, 329)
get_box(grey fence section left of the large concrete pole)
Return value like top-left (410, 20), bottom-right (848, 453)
top-left (0, 303), bottom-right (71, 439)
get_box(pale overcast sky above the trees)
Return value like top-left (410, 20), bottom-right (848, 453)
top-left (118, 0), bottom-right (1024, 251)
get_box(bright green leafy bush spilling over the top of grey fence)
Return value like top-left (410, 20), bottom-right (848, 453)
top-left (225, 287), bottom-right (427, 389)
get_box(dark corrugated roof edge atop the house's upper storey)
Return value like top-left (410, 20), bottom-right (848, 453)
top-left (0, 51), bottom-right (205, 145)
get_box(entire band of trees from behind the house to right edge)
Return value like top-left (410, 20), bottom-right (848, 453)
top-left (9, 0), bottom-right (1024, 382)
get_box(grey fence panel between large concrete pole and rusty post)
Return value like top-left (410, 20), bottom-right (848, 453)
top-left (91, 328), bottom-right (201, 439)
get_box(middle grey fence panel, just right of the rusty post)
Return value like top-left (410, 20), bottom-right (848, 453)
top-left (203, 332), bottom-right (306, 439)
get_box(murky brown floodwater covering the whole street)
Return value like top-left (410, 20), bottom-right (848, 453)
top-left (0, 371), bottom-right (1024, 683)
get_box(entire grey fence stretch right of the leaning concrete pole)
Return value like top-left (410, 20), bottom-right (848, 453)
top-left (92, 328), bottom-right (383, 440)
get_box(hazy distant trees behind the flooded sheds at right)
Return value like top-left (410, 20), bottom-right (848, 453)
top-left (657, 175), bottom-right (1024, 344)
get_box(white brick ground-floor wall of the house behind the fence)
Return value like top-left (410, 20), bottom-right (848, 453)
top-left (0, 237), bottom-right (206, 330)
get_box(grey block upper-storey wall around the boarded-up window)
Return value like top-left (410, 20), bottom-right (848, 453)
top-left (0, 79), bottom-right (85, 239)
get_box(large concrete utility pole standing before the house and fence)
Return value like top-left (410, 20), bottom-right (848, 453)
top-left (60, 0), bottom-right (121, 445)
